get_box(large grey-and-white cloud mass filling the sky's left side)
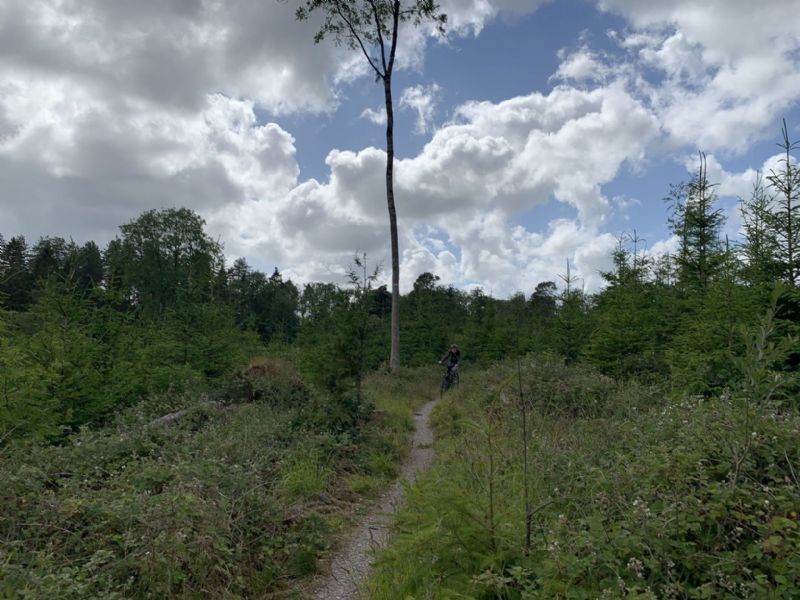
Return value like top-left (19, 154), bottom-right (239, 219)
top-left (0, 0), bottom-right (476, 246)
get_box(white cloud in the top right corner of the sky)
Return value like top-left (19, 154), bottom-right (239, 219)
top-left (598, 0), bottom-right (800, 152)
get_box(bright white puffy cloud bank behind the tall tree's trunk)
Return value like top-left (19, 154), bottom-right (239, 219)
top-left (216, 85), bottom-right (658, 294)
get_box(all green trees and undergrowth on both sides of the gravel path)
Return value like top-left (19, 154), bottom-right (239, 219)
top-left (0, 126), bottom-right (800, 598)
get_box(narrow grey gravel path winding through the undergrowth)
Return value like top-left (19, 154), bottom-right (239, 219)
top-left (310, 401), bottom-right (435, 600)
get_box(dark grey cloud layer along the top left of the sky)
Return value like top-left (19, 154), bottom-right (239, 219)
top-left (0, 0), bottom-right (344, 112)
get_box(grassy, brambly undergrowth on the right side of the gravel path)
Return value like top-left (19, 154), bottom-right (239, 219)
top-left (370, 356), bottom-right (800, 599)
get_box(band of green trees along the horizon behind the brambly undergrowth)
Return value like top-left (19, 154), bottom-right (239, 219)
top-left (0, 124), bottom-right (800, 437)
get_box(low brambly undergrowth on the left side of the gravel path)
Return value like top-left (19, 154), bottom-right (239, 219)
top-left (0, 359), bottom-right (434, 600)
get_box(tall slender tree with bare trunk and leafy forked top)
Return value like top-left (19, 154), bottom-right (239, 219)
top-left (296, 0), bottom-right (447, 372)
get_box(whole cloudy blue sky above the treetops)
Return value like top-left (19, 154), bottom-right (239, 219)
top-left (0, 0), bottom-right (800, 297)
